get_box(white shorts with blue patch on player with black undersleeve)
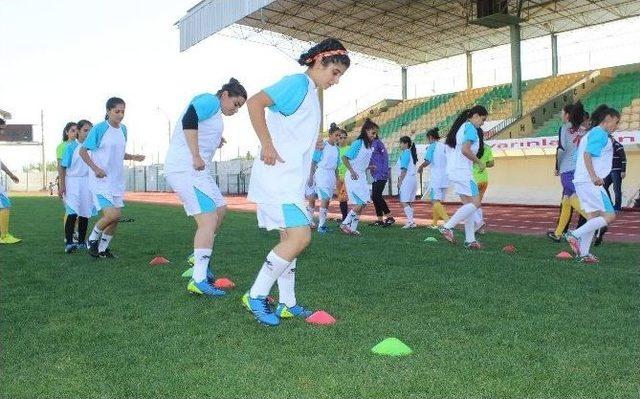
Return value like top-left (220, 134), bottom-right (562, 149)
top-left (165, 169), bottom-right (227, 216)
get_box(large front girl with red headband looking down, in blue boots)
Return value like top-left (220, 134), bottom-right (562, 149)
top-left (243, 38), bottom-right (350, 326)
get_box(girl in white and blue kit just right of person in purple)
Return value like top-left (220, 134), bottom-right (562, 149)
top-left (397, 136), bottom-right (418, 229)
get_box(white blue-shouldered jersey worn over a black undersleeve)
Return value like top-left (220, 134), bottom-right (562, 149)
top-left (164, 93), bottom-right (224, 173)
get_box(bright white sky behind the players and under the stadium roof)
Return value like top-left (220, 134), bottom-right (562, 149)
top-left (0, 0), bottom-right (640, 169)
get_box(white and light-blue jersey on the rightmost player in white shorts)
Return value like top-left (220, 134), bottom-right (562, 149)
top-left (573, 126), bottom-right (613, 183)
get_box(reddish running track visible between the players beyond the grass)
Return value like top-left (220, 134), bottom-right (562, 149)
top-left (125, 192), bottom-right (640, 242)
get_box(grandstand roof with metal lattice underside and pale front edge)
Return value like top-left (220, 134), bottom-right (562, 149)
top-left (177, 0), bottom-right (640, 65)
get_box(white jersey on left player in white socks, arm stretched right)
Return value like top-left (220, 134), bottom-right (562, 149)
top-left (82, 121), bottom-right (127, 196)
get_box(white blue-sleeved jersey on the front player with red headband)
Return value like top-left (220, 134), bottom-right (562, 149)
top-left (247, 73), bottom-right (321, 204)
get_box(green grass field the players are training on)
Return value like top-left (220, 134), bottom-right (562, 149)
top-left (0, 197), bottom-right (640, 398)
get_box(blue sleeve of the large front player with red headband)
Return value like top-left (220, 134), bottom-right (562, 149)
top-left (263, 73), bottom-right (309, 116)
